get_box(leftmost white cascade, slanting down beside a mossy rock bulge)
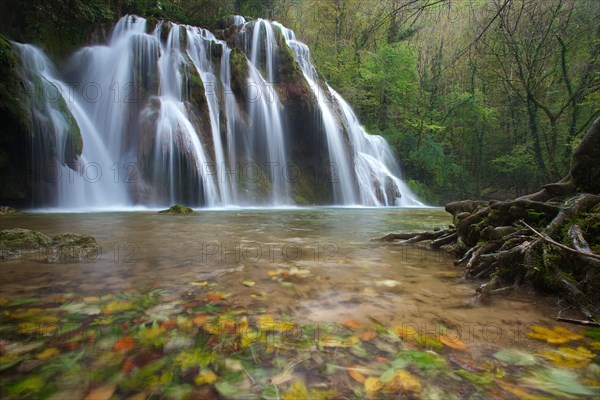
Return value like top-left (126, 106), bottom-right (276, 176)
top-left (15, 43), bottom-right (129, 209)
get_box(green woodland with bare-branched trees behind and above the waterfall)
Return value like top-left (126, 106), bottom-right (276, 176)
top-left (4, 0), bottom-right (600, 204)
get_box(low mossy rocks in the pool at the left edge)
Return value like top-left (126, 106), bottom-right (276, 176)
top-left (0, 228), bottom-right (100, 264)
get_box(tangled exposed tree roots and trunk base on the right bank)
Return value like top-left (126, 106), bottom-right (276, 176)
top-left (373, 119), bottom-right (600, 325)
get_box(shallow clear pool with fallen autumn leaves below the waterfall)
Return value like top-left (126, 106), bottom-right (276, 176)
top-left (0, 207), bottom-right (598, 398)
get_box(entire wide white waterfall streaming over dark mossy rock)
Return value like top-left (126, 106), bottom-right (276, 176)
top-left (15, 16), bottom-right (422, 209)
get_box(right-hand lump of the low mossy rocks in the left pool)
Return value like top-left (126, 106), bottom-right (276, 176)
top-left (45, 233), bottom-right (100, 264)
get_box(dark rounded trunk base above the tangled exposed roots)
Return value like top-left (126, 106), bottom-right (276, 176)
top-left (570, 118), bottom-right (600, 193)
